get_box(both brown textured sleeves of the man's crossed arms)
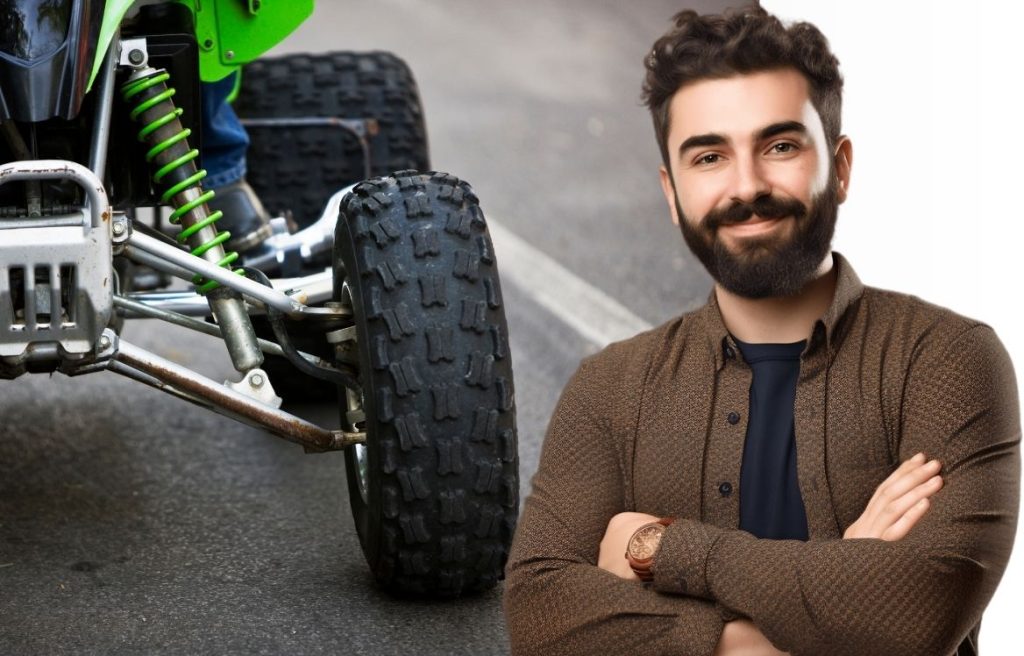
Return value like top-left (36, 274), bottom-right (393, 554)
top-left (506, 326), bottom-right (1020, 656)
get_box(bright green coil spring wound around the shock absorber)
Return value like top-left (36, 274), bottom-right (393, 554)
top-left (121, 71), bottom-right (243, 294)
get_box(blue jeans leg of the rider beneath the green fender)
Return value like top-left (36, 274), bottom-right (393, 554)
top-left (202, 73), bottom-right (249, 189)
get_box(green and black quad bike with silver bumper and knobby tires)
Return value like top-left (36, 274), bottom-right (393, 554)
top-left (0, 0), bottom-right (519, 597)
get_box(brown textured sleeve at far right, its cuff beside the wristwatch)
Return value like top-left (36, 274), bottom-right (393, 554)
top-left (652, 325), bottom-right (1020, 656)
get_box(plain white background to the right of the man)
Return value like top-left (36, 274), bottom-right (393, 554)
top-left (761, 0), bottom-right (1024, 656)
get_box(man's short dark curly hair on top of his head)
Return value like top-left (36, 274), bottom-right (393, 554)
top-left (642, 6), bottom-right (843, 170)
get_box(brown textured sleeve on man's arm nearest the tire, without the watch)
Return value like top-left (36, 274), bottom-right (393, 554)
top-left (504, 355), bottom-right (723, 656)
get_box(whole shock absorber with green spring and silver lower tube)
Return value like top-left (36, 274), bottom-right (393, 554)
top-left (121, 67), bottom-right (263, 373)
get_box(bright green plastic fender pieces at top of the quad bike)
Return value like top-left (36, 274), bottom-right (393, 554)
top-left (89, 0), bottom-right (314, 89)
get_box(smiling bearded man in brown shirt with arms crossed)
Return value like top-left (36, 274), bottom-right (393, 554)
top-left (506, 8), bottom-right (1020, 656)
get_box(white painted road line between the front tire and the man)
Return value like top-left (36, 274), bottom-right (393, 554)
top-left (487, 217), bottom-right (651, 347)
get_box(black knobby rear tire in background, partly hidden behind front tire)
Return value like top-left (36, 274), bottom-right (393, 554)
top-left (234, 52), bottom-right (430, 226)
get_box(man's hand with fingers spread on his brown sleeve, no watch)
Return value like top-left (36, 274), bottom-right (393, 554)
top-left (843, 453), bottom-right (942, 541)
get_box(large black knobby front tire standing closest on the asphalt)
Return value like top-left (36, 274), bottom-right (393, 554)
top-left (335, 171), bottom-right (519, 598)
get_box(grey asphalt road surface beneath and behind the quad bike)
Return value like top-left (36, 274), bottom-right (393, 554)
top-left (0, 0), bottom-right (737, 655)
